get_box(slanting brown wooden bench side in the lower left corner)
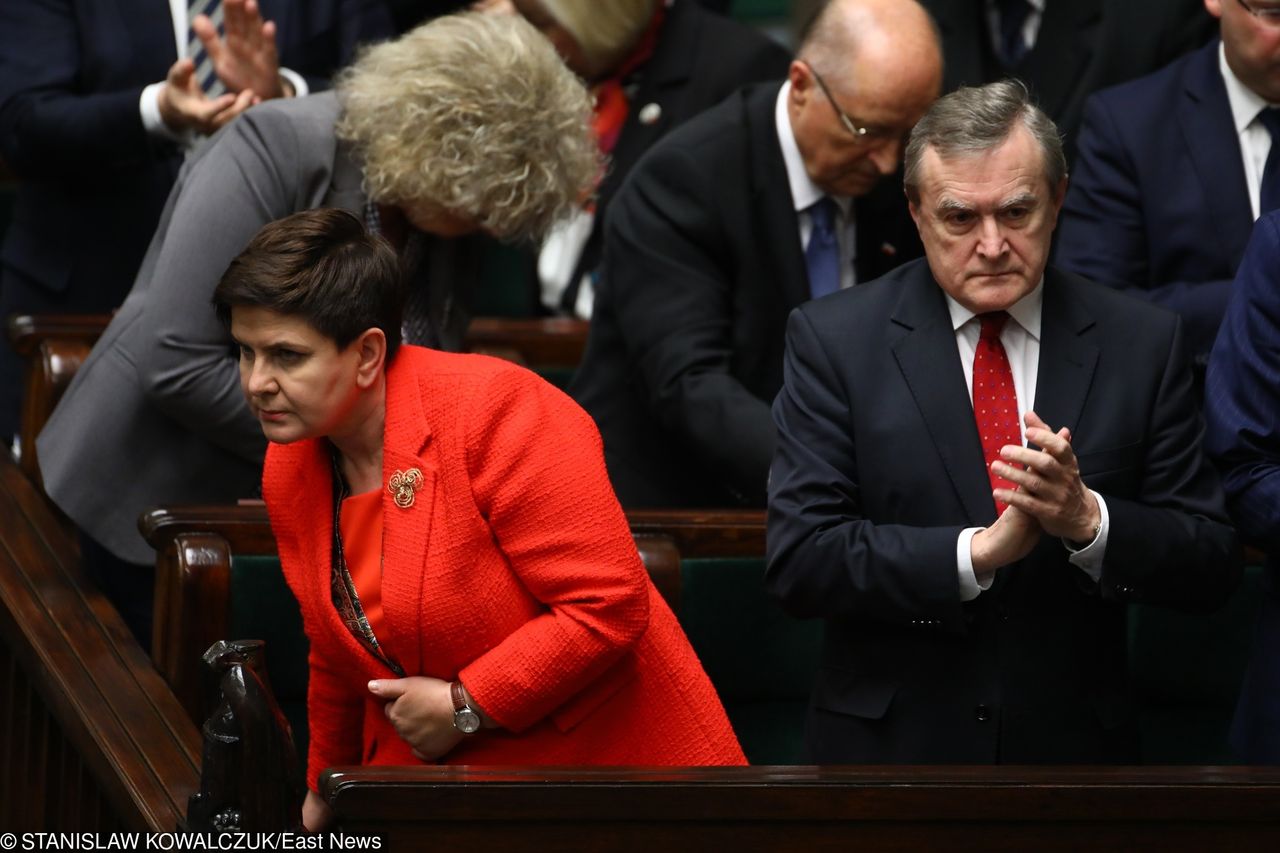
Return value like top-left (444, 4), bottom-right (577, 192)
top-left (0, 453), bottom-right (201, 833)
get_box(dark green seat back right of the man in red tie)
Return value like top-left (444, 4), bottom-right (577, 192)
top-left (1129, 566), bottom-right (1263, 765)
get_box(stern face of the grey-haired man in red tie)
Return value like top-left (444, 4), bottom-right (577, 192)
top-left (910, 127), bottom-right (1066, 314)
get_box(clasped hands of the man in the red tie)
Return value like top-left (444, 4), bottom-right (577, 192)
top-left (972, 411), bottom-right (1101, 575)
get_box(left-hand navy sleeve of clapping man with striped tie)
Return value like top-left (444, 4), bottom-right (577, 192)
top-left (0, 0), bottom-right (173, 181)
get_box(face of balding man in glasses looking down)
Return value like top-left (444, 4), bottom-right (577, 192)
top-left (787, 52), bottom-right (942, 197)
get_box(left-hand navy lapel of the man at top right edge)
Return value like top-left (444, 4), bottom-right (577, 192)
top-left (1178, 40), bottom-right (1253, 266)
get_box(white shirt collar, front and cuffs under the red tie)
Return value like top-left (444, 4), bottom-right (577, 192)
top-left (946, 279), bottom-right (1111, 601)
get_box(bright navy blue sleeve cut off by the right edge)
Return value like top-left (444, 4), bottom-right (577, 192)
top-left (1206, 208), bottom-right (1280, 553)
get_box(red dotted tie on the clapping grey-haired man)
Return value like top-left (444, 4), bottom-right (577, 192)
top-left (973, 311), bottom-right (1023, 515)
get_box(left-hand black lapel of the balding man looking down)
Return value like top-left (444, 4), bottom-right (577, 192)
top-left (742, 85), bottom-right (810, 309)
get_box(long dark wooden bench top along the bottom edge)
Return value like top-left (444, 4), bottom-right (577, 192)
top-left (320, 767), bottom-right (1280, 853)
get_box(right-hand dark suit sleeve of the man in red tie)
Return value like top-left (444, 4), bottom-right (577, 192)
top-left (1101, 315), bottom-right (1240, 610)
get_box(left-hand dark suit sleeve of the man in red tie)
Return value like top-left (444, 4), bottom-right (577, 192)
top-left (765, 304), bottom-right (961, 626)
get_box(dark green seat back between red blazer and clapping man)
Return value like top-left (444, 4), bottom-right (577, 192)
top-left (680, 557), bottom-right (822, 765)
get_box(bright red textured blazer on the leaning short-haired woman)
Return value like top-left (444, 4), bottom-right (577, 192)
top-left (262, 346), bottom-right (745, 788)
